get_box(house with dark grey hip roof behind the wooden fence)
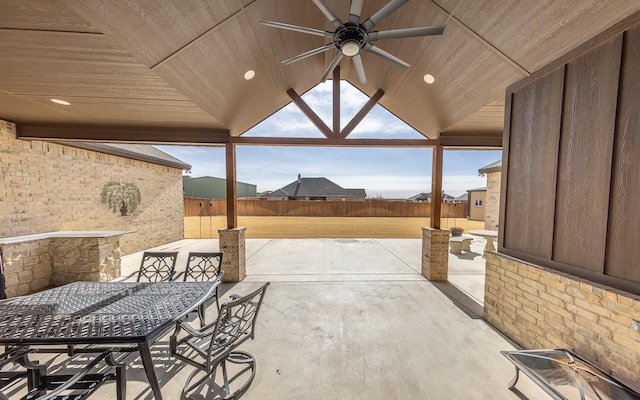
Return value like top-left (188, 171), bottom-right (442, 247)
top-left (268, 175), bottom-right (367, 201)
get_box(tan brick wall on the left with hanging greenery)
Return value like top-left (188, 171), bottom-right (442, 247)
top-left (0, 120), bottom-right (184, 254)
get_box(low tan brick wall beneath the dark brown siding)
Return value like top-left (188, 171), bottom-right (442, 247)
top-left (484, 253), bottom-right (640, 391)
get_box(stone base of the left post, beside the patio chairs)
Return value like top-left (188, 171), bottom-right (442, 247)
top-left (218, 228), bottom-right (247, 282)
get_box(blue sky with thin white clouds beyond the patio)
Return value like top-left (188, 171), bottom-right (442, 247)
top-left (155, 81), bottom-right (502, 199)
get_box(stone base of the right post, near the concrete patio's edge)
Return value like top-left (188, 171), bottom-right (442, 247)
top-left (422, 227), bottom-right (449, 281)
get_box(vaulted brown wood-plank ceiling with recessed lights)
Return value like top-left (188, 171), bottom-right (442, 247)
top-left (0, 0), bottom-right (640, 145)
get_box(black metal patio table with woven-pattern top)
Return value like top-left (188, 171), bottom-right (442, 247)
top-left (0, 281), bottom-right (220, 400)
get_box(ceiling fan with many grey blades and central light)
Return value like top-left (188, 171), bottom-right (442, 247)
top-left (258, 0), bottom-right (444, 84)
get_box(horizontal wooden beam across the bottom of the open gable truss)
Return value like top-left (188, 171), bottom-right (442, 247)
top-left (230, 136), bottom-right (440, 148)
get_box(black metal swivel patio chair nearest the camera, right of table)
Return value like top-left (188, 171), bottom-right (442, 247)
top-left (169, 282), bottom-right (269, 399)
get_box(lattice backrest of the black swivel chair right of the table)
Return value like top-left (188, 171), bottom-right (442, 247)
top-left (207, 282), bottom-right (269, 365)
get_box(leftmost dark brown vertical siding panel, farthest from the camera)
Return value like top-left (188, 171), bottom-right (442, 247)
top-left (504, 68), bottom-right (564, 258)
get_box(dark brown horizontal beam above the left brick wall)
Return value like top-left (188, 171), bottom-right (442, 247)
top-left (16, 124), bottom-right (231, 145)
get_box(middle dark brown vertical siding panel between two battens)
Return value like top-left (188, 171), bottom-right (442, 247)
top-left (553, 36), bottom-right (622, 272)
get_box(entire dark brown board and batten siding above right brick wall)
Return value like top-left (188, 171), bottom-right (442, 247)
top-left (499, 15), bottom-right (640, 294)
